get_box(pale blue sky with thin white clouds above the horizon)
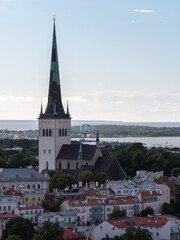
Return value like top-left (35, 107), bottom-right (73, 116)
top-left (0, 0), bottom-right (180, 122)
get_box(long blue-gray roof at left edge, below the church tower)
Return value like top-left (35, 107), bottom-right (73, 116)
top-left (0, 168), bottom-right (49, 182)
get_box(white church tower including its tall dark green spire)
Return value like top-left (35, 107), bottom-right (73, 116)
top-left (38, 19), bottom-right (71, 172)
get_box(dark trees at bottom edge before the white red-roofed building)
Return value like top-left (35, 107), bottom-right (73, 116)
top-left (101, 227), bottom-right (152, 240)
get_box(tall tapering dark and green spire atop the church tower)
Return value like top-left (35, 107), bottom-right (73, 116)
top-left (43, 17), bottom-right (68, 118)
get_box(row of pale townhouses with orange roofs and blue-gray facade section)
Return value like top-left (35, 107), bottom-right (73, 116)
top-left (61, 191), bottom-right (165, 224)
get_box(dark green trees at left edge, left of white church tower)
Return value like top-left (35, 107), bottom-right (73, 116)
top-left (0, 139), bottom-right (38, 168)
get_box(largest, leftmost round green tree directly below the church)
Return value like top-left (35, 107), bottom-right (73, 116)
top-left (49, 171), bottom-right (74, 191)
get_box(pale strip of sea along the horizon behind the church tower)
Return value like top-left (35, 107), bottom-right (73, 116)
top-left (0, 120), bottom-right (180, 131)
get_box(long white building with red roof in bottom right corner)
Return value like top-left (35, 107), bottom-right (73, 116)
top-left (94, 215), bottom-right (180, 240)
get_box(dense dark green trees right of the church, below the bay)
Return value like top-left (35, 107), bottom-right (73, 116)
top-left (101, 143), bottom-right (180, 177)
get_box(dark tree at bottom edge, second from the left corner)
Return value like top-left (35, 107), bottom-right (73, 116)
top-left (32, 221), bottom-right (64, 240)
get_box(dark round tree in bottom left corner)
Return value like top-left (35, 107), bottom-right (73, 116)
top-left (2, 217), bottom-right (35, 240)
